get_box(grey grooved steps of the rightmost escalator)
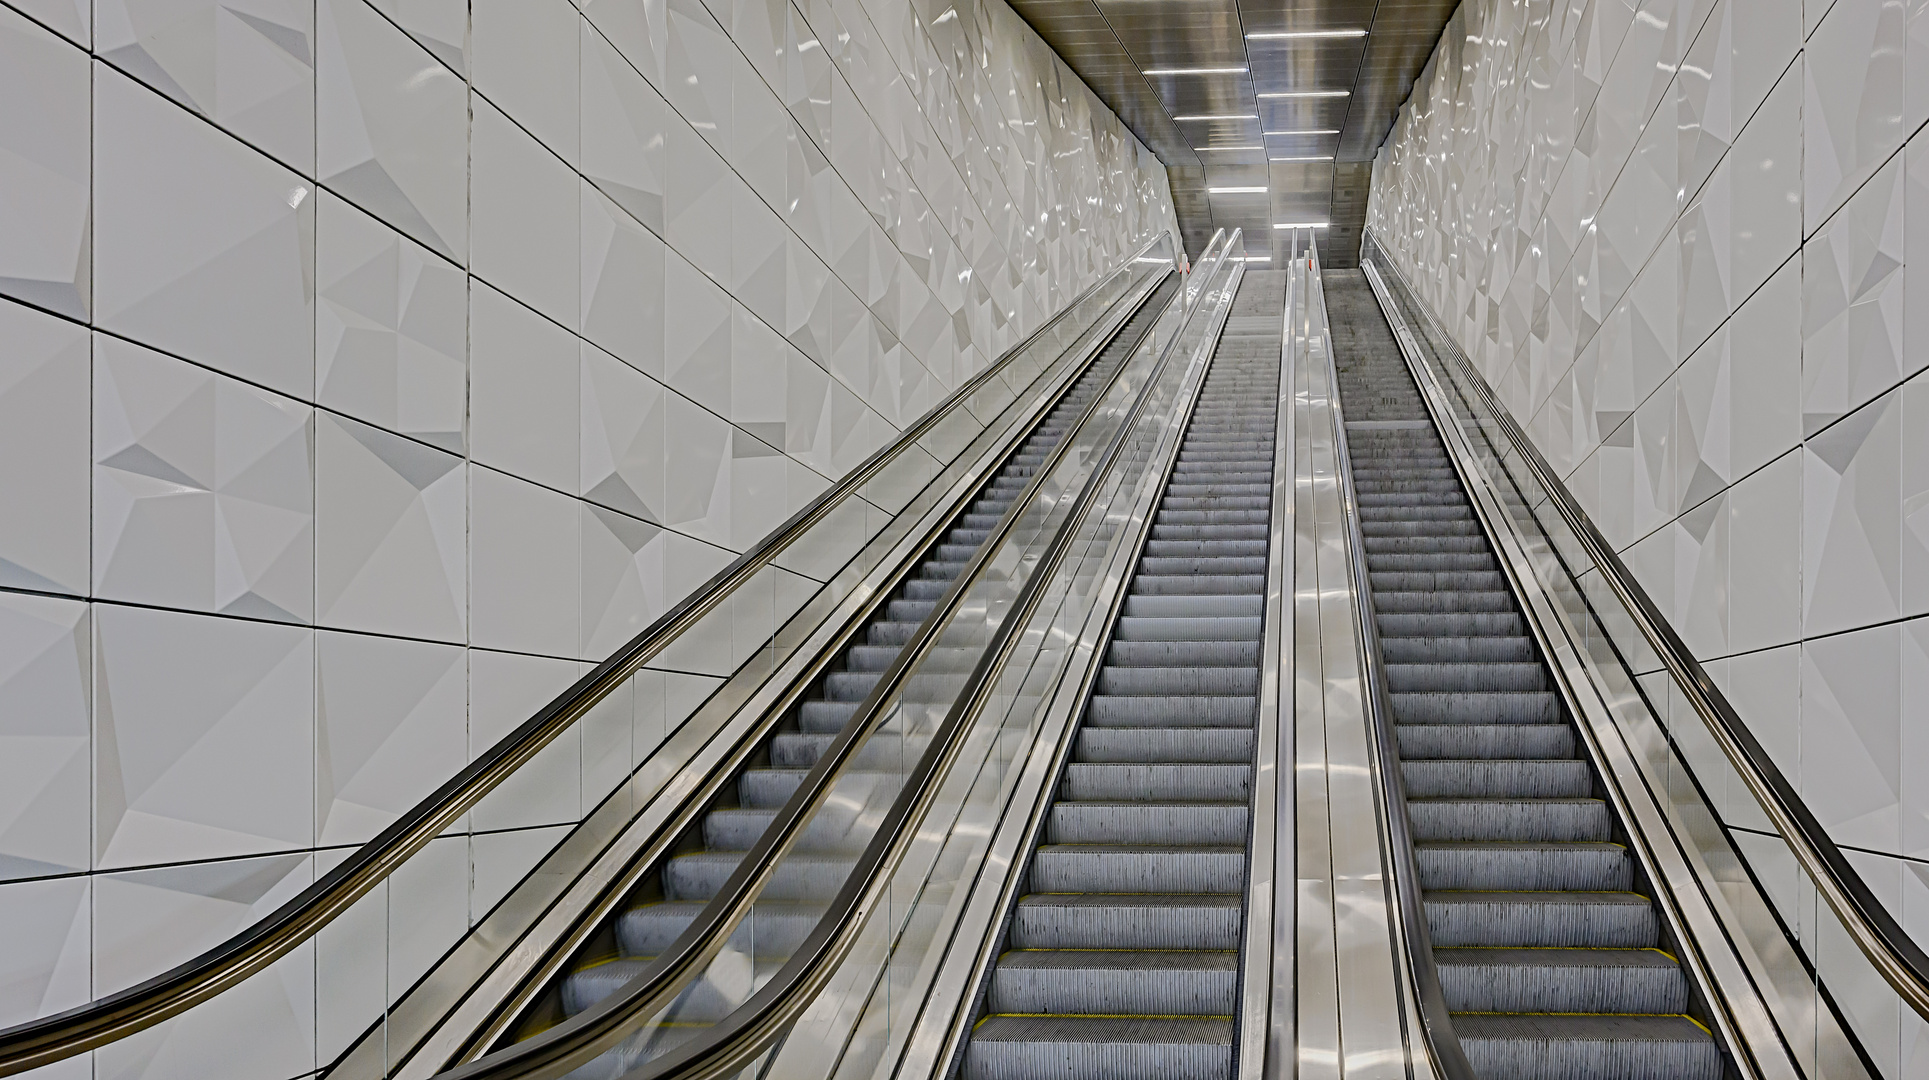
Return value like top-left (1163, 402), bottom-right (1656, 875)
top-left (1325, 270), bottom-right (1723, 1080)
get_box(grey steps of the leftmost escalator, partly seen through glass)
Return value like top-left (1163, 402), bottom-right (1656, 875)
top-left (561, 280), bottom-right (1179, 1026)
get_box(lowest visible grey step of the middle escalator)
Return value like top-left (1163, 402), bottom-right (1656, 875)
top-left (963, 1016), bottom-right (1233, 1080)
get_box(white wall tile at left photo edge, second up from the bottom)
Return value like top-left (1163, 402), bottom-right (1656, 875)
top-left (0, 594), bottom-right (93, 883)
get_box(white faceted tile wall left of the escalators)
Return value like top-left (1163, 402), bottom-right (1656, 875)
top-left (0, 0), bottom-right (1175, 1080)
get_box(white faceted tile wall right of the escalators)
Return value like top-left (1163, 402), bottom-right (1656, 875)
top-left (1370, 0), bottom-right (1929, 939)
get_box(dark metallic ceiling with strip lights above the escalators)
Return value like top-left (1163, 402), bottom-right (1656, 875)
top-left (1011, 0), bottom-right (1458, 266)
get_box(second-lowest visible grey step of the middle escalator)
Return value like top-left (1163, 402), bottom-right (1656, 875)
top-left (986, 949), bottom-right (1238, 1016)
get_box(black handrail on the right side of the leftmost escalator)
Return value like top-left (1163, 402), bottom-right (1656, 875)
top-left (438, 264), bottom-right (1195, 1080)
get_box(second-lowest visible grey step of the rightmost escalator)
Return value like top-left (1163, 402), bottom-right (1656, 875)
top-left (1435, 949), bottom-right (1688, 1013)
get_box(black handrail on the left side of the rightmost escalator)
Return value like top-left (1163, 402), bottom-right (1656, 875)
top-left (1308, 243), bottom-right (1476, 1080)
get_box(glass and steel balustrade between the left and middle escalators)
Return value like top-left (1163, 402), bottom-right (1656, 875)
top-left (489, 238), bottom-right (1238, 1076)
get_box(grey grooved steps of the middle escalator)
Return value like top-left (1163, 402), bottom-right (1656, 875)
top-left (963, 272), bottom-right (1285, 1080)
